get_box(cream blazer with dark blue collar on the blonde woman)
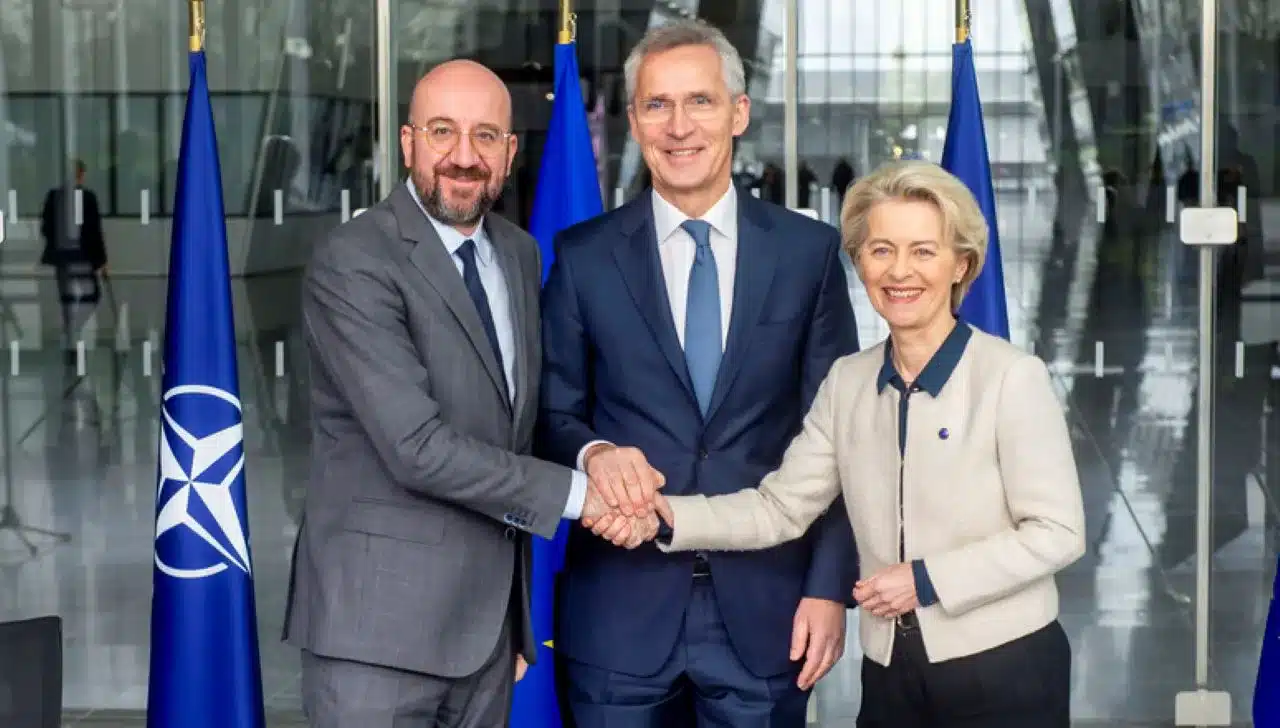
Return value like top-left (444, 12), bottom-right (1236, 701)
top-left (659, 329), bottom-right (1084, 665)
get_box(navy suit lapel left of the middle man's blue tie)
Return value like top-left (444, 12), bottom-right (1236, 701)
top-left (613, 202), bottom-right (696, 402)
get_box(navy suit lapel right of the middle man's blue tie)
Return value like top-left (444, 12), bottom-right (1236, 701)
top-left (705, 194), bottom-right (778, 422)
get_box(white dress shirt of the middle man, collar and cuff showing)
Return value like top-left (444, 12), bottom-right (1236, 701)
top-left (577, 184), bottom-right (737, 470)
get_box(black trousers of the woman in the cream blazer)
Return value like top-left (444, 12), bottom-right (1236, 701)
top-left (858, 622), bottom-right (1071, 728)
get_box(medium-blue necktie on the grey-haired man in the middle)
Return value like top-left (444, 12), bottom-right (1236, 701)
top-left (681, 220), bottom-right (723, 415)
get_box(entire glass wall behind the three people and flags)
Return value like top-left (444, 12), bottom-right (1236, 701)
top-left (0, 0), bottom-right (1280, 725)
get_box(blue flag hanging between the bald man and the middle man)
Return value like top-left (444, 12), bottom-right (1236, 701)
top-left (511, 44), bottom-right (604, 728)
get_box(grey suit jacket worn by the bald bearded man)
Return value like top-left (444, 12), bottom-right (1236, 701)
top-left (284, 186), bottom-right (572, 678)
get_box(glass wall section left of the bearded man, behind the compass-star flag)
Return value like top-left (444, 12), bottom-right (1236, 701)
top-left (0, 0), bottom-right (379, 711)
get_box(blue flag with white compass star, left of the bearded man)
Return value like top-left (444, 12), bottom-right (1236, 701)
top-left (147, 46), bottom-right (265, 728)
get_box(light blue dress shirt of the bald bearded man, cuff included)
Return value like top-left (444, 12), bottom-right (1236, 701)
top-left (404, 182), bottom-right (588, 521)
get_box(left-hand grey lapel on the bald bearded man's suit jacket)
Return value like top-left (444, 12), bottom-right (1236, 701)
top-left (390, 184), bottom-right (509, 407)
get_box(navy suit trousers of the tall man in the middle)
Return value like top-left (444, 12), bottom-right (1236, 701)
top-left (566, 576), bottom-right (809, 728)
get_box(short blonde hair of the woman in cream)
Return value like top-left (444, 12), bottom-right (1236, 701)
top-left (840, 160), bottom-right (988, 311)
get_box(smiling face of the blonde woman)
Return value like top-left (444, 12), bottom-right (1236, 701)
top-left (858, 200), bottom-right (969, 330)
